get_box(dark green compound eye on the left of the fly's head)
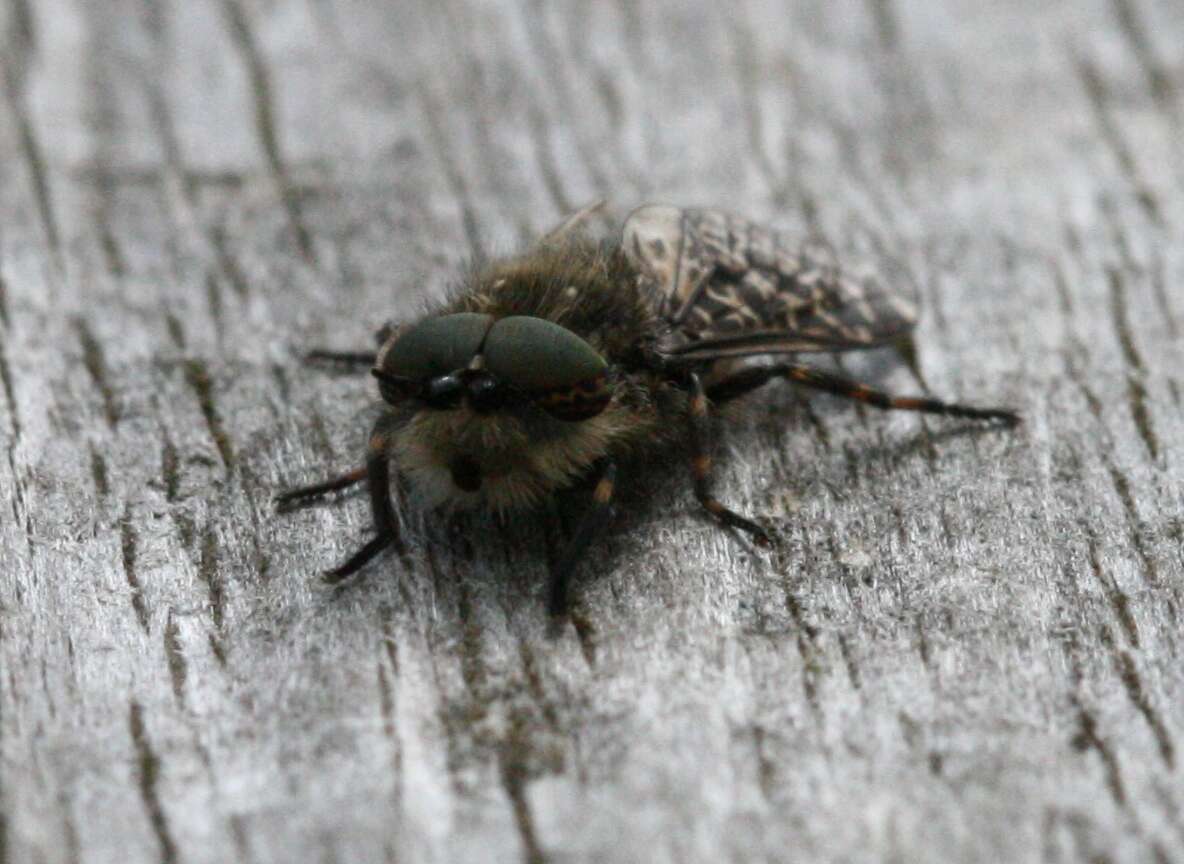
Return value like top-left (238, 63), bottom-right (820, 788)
top-left (374, 312), bottom-right (494, 407)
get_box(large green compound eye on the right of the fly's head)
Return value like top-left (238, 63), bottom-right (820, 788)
top-left (483, 315), bottom-right (612, 421)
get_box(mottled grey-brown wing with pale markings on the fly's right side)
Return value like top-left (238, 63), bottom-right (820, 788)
top-left (622, 205), bottom-right (916, 360)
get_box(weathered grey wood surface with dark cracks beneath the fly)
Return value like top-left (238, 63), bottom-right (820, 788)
top-left (0, 0), bottom-right (1184, 864)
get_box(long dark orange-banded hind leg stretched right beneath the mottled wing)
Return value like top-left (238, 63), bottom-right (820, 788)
top-left (707, 363), bottom-right (1019, 426)
